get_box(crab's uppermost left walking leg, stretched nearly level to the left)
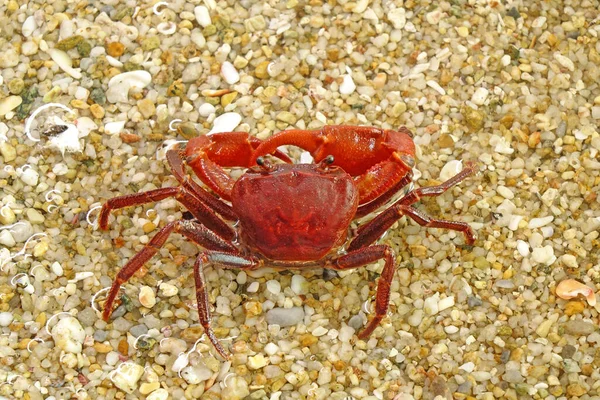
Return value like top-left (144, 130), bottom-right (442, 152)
top-left (98, 187), bottom-right (235, 240)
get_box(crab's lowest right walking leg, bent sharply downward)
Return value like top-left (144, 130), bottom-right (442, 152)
top-left (326, 245), bottom-right (396, 339)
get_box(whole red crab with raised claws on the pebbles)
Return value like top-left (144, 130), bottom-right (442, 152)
top-left (99, 126), bottom-right (475, 358)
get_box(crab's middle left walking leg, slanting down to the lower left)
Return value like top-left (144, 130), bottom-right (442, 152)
top-left (102, 220), bottom-right (237, 321)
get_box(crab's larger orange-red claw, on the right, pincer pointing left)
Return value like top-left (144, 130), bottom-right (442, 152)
top-left (252, 126), bottom-right (415, 204)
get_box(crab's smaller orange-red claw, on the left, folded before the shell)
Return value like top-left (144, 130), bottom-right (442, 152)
top-left (185, 132), bottom-right (291, 200)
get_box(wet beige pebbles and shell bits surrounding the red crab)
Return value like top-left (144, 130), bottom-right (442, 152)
top-left (0, 0), bottom-right (600, 400)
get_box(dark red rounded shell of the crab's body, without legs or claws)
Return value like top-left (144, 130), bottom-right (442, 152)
top-left (231, 164), bottom-right (358, 261)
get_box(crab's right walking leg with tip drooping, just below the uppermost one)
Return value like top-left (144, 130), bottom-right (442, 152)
top-left (348, 204), bottom-right (475, 251)
